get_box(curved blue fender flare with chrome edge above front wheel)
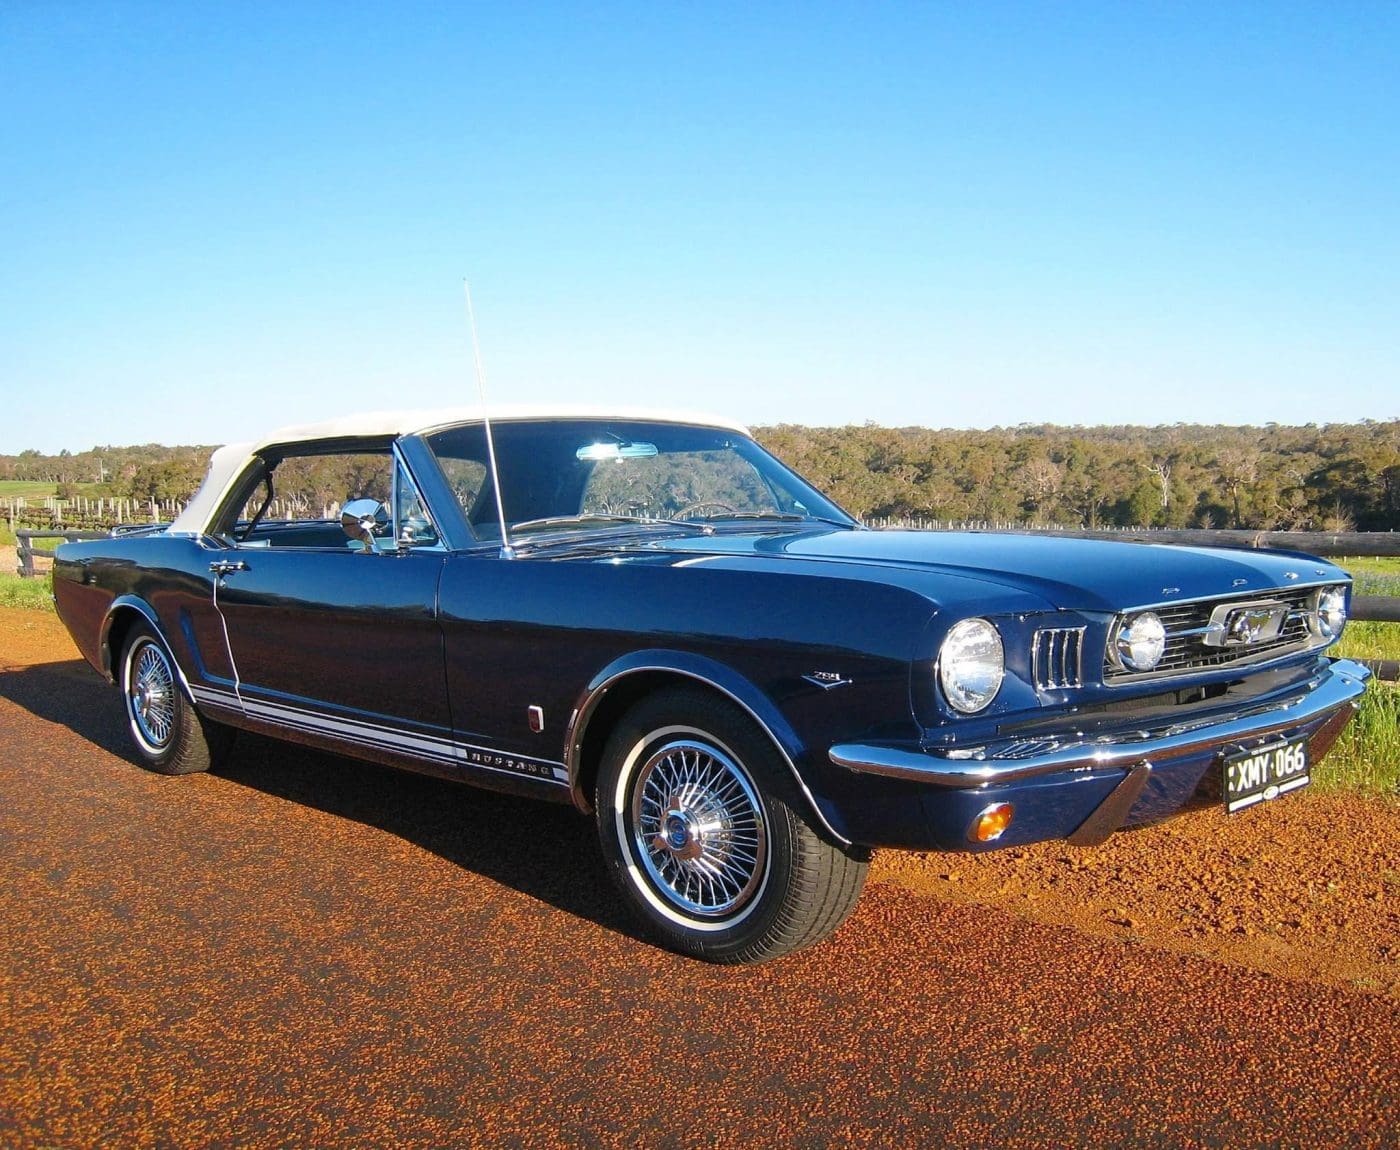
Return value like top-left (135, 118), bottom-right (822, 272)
top-left (564, 649), bottom-right (850, 846)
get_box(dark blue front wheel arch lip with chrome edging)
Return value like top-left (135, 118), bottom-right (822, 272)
top-left (564, 650), bottom-right (851, 846)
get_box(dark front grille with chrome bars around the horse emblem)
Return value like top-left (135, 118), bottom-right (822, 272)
top-left (1103, 587), bottom-right (1315, 682)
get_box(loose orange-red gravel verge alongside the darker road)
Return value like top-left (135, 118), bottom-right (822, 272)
top-left (0, 608), bottom-right (1400, 999)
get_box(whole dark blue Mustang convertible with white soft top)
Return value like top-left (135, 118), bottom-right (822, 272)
top-left (53, 412), bottom-right (1368, 962)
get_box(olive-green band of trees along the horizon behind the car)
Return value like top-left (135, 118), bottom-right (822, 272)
top-left (0, 420), bottom-right (1400, 531)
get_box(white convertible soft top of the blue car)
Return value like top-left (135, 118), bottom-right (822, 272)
top-left (169, 406), bottom-right (750, 535)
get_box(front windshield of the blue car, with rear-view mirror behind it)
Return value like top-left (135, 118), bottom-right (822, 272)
top-left (427, 420), bottom-right (854, 538)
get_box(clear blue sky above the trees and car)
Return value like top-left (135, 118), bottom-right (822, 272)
top-left (0, 0), bottom-right (1400, 452)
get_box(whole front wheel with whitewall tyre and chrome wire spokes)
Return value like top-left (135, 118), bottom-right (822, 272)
top-left (596, 689), bottom-right (868, 962)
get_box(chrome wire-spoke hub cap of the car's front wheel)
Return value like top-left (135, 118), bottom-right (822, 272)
top-left (631, 740), bottom-right (767, 917)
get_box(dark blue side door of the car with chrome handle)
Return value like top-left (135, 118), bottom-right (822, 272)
top-left (213, 452), bottom-right (456, 766)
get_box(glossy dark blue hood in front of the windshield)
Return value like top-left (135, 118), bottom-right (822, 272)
top-left (624, 531), bottom-right (1347, 611)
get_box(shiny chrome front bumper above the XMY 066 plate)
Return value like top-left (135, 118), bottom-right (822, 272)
top-left (829, 660), bottom-right (1371, 787)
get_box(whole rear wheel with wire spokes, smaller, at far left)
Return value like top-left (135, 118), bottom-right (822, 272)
top-left (120, 623), bottom-right (232, 775)
